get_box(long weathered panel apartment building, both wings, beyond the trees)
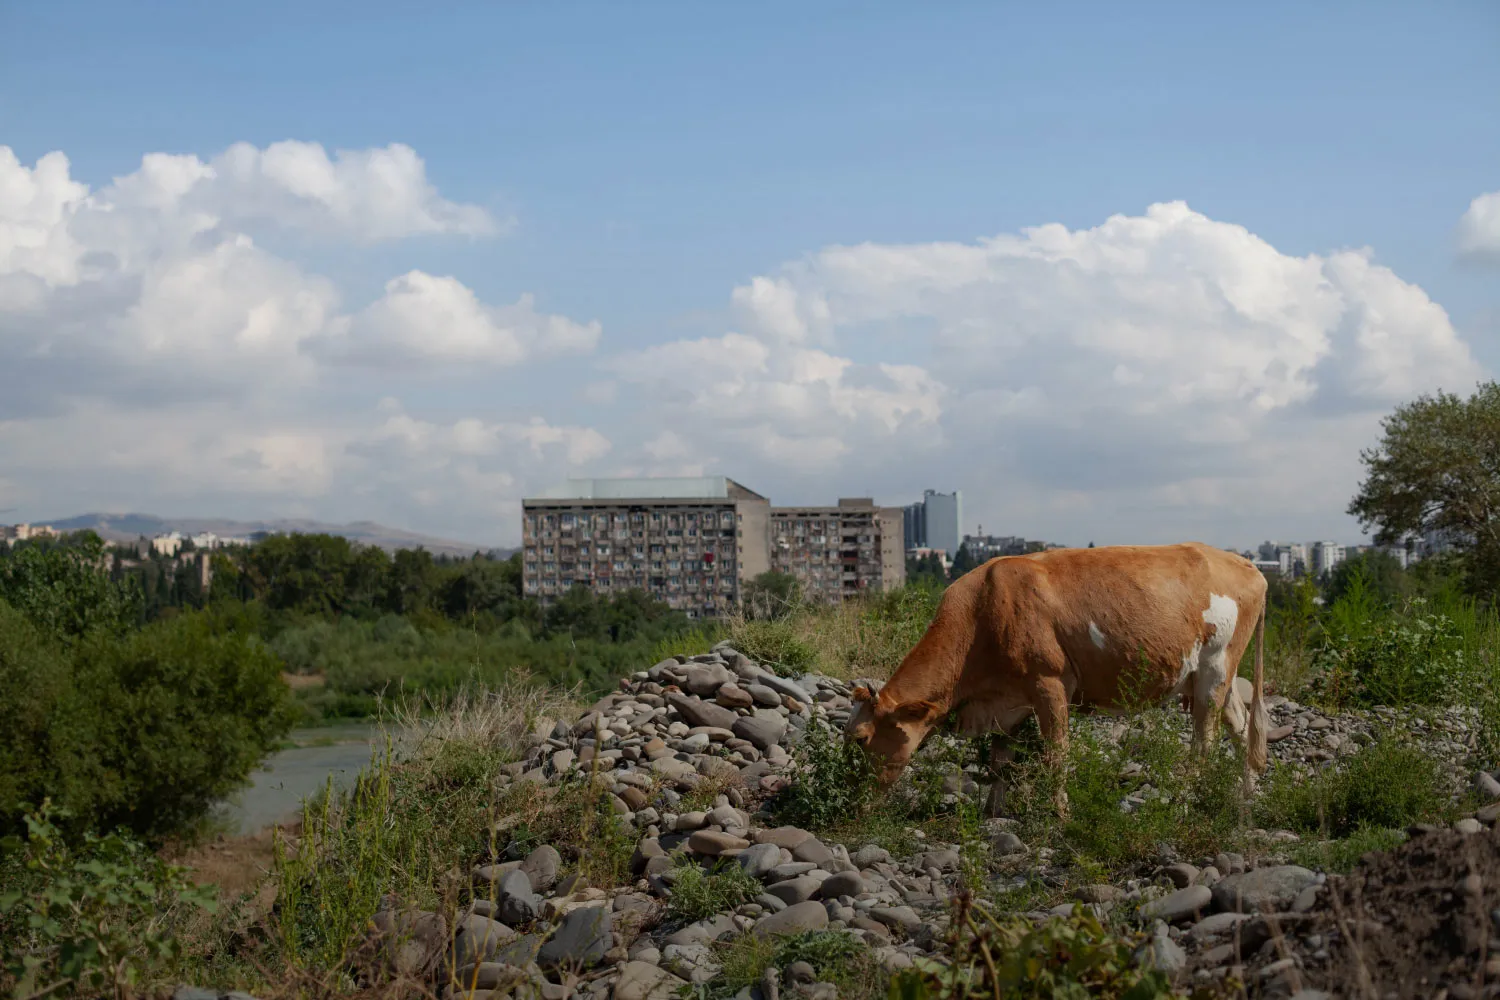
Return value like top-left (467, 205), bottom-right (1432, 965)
top-left (522, 475), bottom-right (906, 618)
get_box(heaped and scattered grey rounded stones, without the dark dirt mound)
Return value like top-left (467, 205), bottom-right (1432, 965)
top-left (181, 643), bottom-right (1500, 1000)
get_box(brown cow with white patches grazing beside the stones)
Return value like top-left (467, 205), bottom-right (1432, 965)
top-left (846, 543), bottom-right (1268, 814)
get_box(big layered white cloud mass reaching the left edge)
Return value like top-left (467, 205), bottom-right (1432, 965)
top-left (0, 142), bottom-right (611, 541)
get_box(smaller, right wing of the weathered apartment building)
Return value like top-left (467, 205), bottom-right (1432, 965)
top-left (771, 496), bottom-right (906, 604)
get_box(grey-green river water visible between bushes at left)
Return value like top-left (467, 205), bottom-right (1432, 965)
top-left (215, 723), bottom-right (380, 837)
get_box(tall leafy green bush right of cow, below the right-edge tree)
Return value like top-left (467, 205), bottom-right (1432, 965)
top-left (1313, 593), bottom-right (1469, 708)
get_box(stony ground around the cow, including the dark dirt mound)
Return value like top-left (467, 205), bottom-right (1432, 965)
top-left (199, 645), bottom-right (1500, 1000)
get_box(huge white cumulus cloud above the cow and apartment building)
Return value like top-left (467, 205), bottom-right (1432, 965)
top-left (609, 202), bottom-right (1481, 540)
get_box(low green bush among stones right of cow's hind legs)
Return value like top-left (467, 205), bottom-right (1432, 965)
top-left (1256, 736), bottom-right (1449, 838)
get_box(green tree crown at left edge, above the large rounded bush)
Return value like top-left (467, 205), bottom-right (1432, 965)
top-left (0, 532), bottom-right (143, 640)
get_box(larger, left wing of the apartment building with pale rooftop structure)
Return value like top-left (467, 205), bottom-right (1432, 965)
top-left (521, 475), bottom-right (771, 618)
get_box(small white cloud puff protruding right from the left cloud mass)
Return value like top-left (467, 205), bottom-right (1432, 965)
top-left (320, 271), bottom-right (600, 366)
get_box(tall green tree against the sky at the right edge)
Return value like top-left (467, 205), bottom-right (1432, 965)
top-left (1349, 381), bottom-right (1500, 592)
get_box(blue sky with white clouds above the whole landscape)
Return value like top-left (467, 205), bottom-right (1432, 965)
top-left (0, 0), bottom-right (1500, 547)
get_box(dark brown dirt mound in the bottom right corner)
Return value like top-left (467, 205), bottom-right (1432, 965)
top-left (1272, 828), bottom-right (1500, 1000)
